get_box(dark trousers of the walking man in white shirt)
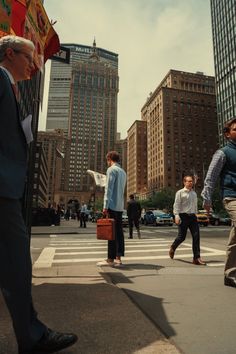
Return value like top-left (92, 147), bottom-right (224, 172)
top-left (172, 214), bottom-right (200, 259)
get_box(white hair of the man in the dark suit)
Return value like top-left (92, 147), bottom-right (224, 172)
top-left (0, 35), bottom-right (35, 62)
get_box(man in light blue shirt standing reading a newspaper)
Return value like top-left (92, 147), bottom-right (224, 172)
top-left (97, 151), bottom-right (126, 267)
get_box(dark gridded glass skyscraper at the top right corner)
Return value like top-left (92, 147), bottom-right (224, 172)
top-left (211, 0), bottom-right (236, 146)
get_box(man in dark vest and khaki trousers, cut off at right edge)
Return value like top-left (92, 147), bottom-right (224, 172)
top-left (201, 117), bottom-right (236, 288)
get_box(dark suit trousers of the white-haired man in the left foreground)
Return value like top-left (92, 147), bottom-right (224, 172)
top-left (0, 198), bottom-right (46, 351)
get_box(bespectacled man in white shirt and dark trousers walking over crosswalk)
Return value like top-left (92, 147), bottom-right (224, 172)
top-left (169, 175), bottom-right (206, 265)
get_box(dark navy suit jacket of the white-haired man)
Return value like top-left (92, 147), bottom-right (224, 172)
top-left (0, 68), bottom-right (27, 199)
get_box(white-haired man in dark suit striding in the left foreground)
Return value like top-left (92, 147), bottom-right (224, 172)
top-left (0, 35), bottom-right (77, 354)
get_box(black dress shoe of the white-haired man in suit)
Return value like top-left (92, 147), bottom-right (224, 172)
top-left (30, 328), bottom-right (78, 354)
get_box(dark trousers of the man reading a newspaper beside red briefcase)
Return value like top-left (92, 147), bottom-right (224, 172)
top-left (108, 209), bottom-right (125, 259)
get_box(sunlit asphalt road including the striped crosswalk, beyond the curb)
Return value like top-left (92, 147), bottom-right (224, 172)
top-left (28, 221), bottom-right (236, 354)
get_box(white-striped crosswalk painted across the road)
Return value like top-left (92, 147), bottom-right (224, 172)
top-left (34, 231), bottom-right (225, 268)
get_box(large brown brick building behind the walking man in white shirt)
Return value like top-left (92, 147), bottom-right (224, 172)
top-left (141, 70), bottom-right (218, 194)
